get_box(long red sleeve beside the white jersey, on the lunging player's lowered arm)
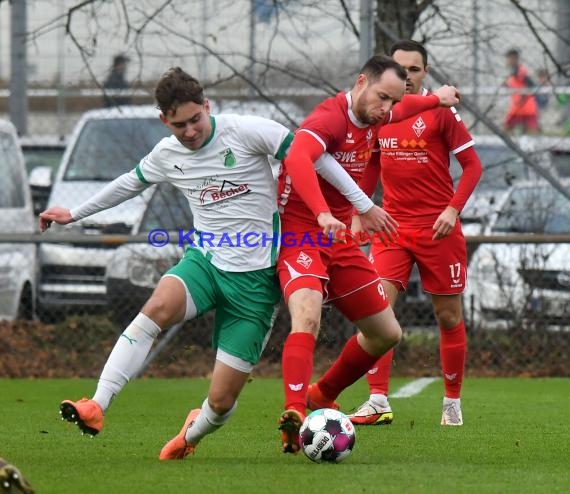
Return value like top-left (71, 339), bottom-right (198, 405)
top-left (283, 132), bottom-right (330, 217)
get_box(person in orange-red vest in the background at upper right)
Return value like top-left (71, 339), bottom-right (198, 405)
top-left (503, 49), bottom-right (540, 134)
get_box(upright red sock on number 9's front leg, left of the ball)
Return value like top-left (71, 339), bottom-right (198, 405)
top-left (281, 333), bottom-right (315, 416)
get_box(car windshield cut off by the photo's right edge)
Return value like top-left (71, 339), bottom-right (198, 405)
top-left (492, 186), bottom-right (570, 234)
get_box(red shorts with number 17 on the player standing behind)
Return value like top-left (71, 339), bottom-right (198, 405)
top-left (370, 221), bottom-right (467, 295)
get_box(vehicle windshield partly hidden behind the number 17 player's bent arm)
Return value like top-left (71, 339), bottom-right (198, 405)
top-left (450, 145), bottom-right (529, 190)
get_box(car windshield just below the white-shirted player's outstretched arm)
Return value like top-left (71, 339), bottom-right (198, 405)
top-left (139, 183), bottom-right (193, 233)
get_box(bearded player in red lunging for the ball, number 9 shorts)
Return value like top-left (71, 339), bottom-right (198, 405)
top-left (277, 55), bottom-right (458, 453)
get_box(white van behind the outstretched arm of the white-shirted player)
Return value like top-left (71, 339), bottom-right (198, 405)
top-left (37, 106), bottom-right (169, 319)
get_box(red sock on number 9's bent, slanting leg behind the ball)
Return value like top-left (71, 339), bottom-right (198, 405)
top-left (318, 335), bottom-right (378, 400)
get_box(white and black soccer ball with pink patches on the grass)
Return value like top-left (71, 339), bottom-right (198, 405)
top-left (299, 408), bottom-right (356, 463)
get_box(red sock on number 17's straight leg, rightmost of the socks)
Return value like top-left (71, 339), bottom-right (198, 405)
top-left (439, 321), bottom-right (467, 398)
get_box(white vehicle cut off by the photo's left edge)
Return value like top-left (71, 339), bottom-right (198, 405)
top-left (0, 120), bottom-right (37, 319)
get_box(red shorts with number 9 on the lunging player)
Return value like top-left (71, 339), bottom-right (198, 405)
top-left (277, 234), bottom-right (389, 321)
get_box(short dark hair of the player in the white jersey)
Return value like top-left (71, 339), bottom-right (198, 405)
top-left (154, 67), bottom-right (204, 115)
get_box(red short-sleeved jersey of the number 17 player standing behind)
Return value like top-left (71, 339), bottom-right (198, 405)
top-left (378, 89), bottom-right (474, 227)
